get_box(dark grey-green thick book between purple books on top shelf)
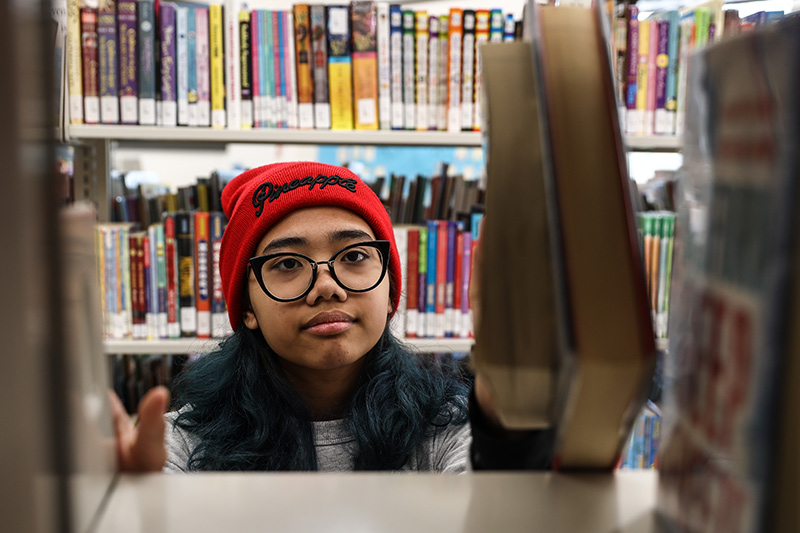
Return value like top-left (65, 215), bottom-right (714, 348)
top-left (136, 0), bottom-right (158, 126)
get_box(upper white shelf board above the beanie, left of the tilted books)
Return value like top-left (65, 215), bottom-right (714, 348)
top-left (69, 125), bottom-right (482, 146)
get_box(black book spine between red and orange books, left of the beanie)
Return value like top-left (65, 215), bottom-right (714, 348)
top-left (175, 211), bottom-right (197, 337)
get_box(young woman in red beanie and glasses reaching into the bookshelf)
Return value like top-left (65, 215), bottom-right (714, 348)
top-left (113, 163), bottom-right (552, 472)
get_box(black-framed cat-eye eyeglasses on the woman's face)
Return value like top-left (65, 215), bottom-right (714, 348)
top-left (250, 241), bottom-right (390, 302)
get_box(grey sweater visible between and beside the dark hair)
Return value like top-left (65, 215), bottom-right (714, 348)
top-left (164, 412), bottom-right (472, 473)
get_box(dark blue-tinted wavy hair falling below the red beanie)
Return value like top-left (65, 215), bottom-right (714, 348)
top-left (170, 326), bottom-right (469, 470)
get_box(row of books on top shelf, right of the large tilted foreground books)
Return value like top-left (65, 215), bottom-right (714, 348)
top-left (614, 2), bottom-right (783, 135)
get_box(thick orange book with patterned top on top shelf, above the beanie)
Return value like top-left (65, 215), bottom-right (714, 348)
top-left (350, 1), bottom-right (379, 130)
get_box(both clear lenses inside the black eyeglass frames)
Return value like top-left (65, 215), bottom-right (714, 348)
top-left (255, 246), bottom-right (383, 299)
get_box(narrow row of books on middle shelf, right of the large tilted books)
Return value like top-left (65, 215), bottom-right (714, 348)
top-left (638, 211), bottom-right (675, 339)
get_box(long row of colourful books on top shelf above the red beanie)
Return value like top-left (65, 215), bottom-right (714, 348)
top-left (67, 0), bottom-right (521, 131)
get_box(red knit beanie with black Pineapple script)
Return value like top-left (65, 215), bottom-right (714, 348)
top-left (219, 162), bottom-right (402, 331)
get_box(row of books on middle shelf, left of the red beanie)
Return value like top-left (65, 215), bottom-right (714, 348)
top-left (95, 211), bottom-right (230, 340)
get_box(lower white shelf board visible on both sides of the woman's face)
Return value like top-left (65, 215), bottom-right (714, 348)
top-left (103, 337), bottom-right (473, 354)
